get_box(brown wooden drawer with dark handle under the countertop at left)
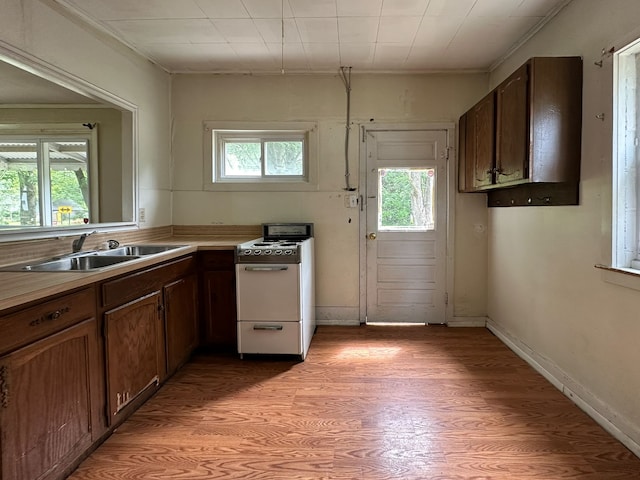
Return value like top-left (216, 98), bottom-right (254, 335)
top-left (0, 288), bottom-right (96, 353)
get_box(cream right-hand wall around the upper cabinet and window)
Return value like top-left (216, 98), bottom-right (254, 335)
top-left (488, 0), bottom-right (640, 451)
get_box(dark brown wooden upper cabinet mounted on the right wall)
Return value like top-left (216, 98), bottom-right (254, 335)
top-left (459, 57), bottom-right (582, 192)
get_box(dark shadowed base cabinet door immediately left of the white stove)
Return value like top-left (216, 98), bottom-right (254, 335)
top-left (200, 265), bottom-right (238, 351)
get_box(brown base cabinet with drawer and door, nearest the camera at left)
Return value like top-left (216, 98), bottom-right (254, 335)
top-left (0, 288), bottom-right (104, 480)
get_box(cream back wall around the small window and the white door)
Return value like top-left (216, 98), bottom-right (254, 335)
top-left (172, 72), bottom-right (488, 323)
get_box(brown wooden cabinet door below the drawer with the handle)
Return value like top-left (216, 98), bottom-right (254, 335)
top-left (0, 319), bottom-right (99, 480)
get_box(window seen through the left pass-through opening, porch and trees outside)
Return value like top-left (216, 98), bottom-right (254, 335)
top-left (0, 125), bottom-right (97, 229)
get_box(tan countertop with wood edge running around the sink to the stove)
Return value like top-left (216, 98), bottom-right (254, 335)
top-left (0, 236), bottom-right (255, 311)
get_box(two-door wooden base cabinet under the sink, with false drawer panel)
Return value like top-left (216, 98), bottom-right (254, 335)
top-left (101, 257), bottom-right (197, 425)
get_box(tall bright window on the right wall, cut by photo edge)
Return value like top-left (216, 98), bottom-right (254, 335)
top-left (613, 39), bottom-right (640, 270)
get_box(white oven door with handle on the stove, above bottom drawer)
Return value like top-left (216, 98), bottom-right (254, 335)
top-left (236, 263), bottom-right (302, 322)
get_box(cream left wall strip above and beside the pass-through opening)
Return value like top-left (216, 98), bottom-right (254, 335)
top-left (0, 0), bottom-right (171, 227)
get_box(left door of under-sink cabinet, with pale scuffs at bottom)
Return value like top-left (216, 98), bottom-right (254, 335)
top-left (104, 291), bottom-right (164, 424)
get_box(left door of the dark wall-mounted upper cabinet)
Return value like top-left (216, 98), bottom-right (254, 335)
top-left (467, 92), bottom-right (495, 189)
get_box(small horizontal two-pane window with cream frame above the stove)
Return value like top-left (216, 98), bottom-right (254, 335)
top-left (205, 122), bottom-right (316, 190)
